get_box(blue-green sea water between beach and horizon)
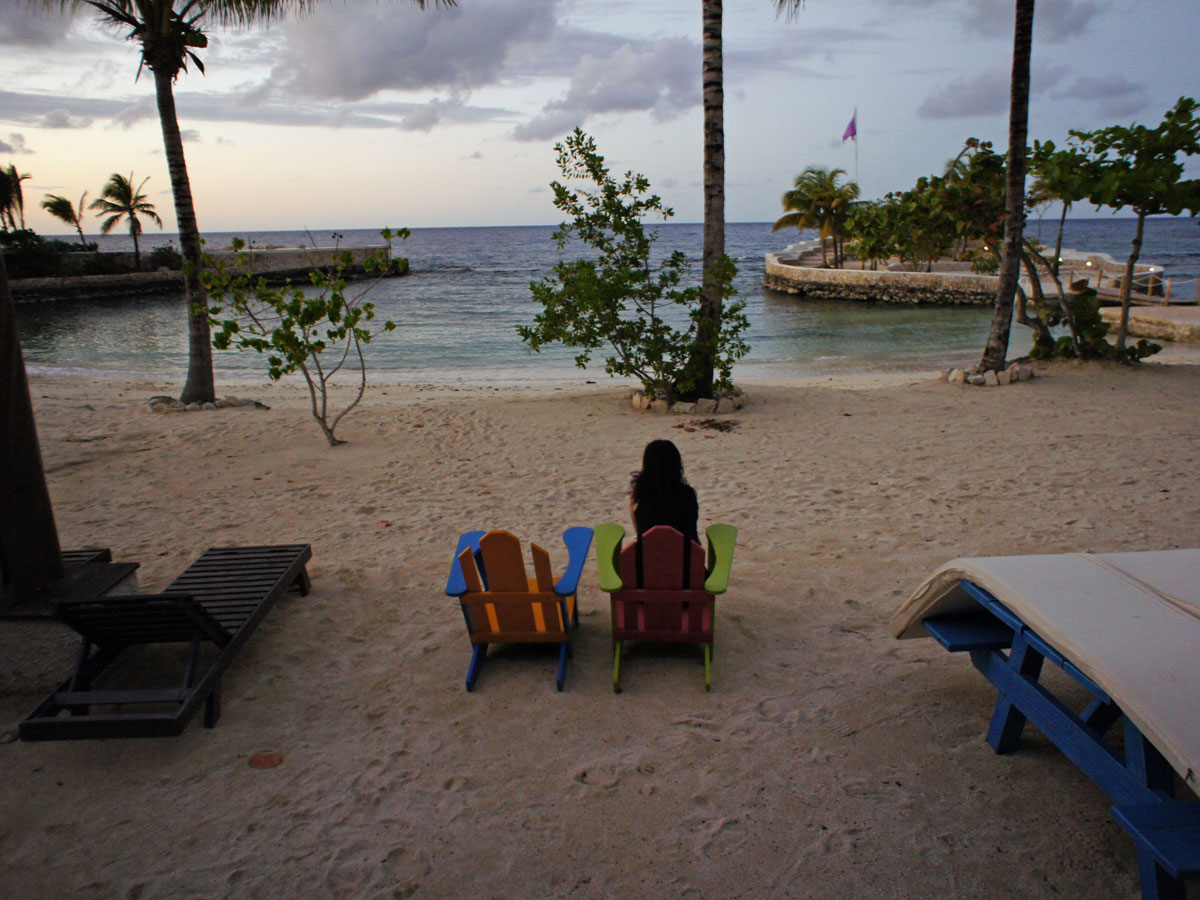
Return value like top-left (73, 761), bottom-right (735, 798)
top-left (17, 218), bottom-right (1200, 384)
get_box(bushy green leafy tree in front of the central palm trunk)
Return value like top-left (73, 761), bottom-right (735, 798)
top-left (517, 128), bottom-right (749, 401)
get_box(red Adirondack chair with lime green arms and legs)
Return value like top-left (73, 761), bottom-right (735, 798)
top-left (596, 522), bottom-right (738, 694)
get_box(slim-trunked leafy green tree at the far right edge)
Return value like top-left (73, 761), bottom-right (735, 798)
top-left (1070, 97), bottom-right (1200, 352)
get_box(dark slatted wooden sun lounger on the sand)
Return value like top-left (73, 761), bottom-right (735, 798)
top-left (19, 544), bottom-right (312, 740)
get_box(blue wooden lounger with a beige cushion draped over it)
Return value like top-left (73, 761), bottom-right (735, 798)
top-left (892, 550), bottom-right (1200, 900)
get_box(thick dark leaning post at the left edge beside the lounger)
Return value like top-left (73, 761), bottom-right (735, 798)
top-left (0, 256), bottom-right (62, 594)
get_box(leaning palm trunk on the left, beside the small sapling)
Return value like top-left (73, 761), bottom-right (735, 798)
top-left (152, 67), bottom-right (216, 403)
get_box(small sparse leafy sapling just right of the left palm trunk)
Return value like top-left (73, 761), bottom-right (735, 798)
top-left (201, 228), bottom-right (409, 446)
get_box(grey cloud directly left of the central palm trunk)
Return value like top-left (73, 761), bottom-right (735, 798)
top-left (512, 37), bottom-right (701, 140)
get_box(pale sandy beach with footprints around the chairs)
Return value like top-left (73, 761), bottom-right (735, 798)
top-left (0, 362), bottom-right (1200, 900)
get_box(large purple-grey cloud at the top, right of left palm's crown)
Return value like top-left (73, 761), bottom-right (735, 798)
top-left (264, 0), bottom-right (558, 101)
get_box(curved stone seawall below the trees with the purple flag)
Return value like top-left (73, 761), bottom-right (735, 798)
top-left (763, 253), bottom-right (1000, 306)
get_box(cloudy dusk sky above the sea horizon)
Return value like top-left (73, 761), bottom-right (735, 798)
top-left (0, 0), bottom-right (1200, 234)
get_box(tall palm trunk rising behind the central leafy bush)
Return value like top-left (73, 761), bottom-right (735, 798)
top-left (694, 0), bottom-right (725, 397)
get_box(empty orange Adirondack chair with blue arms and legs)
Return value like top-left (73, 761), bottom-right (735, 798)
top-left (446, 528), bottom-right (592, 691)
